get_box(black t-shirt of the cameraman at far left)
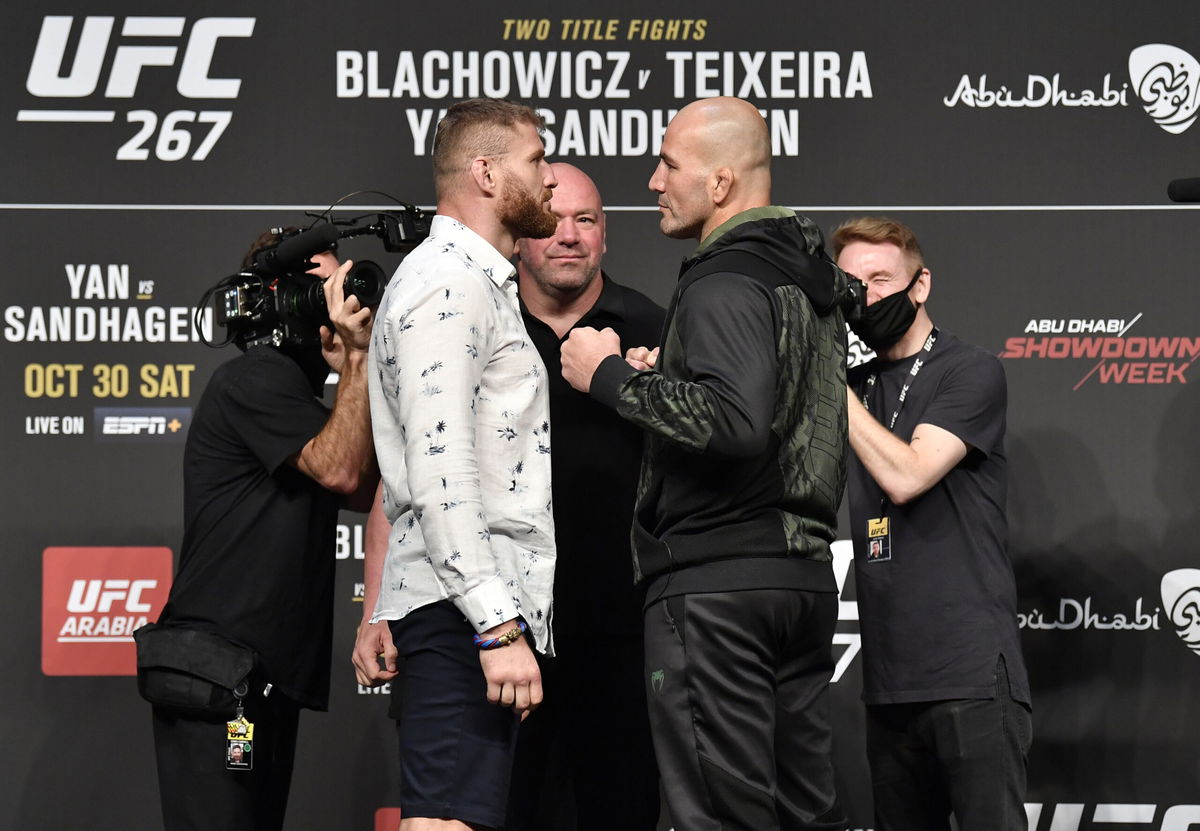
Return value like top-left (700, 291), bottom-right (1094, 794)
top-left (162, 346), bottom-right (340, 710)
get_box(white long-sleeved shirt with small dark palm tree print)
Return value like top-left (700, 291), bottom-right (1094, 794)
top-left (368, 216), bottom-right (554, 651)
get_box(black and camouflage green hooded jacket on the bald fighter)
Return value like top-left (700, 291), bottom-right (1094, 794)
top-left (592, 208), bottom-right (847, 600)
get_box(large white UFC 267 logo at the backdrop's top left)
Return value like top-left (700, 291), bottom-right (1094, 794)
top-left (17, 14), bottom-right (254, 162)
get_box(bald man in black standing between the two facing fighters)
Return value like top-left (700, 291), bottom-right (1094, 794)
top-left (504, 163), bottom-right (664, 831)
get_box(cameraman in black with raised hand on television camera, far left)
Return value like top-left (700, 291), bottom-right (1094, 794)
top-left (154, 232), bottom-right (378, 831)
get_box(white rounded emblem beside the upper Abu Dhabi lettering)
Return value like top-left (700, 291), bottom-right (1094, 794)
top-left (1129, 43), bottom-right (1200, 136)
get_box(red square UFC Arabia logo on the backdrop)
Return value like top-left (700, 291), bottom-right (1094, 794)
top-left (42, 546), bottom-right (172, 675)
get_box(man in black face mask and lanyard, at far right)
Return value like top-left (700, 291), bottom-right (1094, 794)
top-left (833, 217), bottom-right (1032, 831)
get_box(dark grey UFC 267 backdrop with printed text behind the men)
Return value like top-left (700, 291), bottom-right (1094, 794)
top-left (0, 0), bottom-right (1200, 831)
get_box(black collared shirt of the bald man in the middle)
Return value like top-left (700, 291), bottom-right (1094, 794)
top-left (521, 275), bottom-right (665, 653)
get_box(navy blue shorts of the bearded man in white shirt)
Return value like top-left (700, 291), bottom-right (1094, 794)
top-left (390, 600), bottom-right (521, 829)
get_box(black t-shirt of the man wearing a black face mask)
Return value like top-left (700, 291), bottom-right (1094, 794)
top-left (848, 331), bottom-right (1030, 704)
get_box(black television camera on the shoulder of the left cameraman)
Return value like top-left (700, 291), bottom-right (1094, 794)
top-left (206, 205), bottom-right (430, 349)
